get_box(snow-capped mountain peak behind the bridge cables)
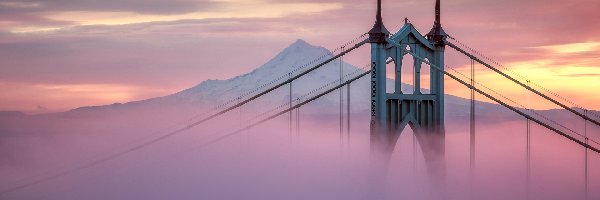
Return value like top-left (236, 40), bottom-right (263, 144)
top-left (169, 40), bottom-right (358, 103)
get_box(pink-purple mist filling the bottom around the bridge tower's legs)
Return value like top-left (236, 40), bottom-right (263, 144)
top-left (0, 111), bottom-right (600, 200)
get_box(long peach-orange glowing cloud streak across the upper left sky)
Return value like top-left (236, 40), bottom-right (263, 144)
top-left (4, 1), bottom-right (341, 33)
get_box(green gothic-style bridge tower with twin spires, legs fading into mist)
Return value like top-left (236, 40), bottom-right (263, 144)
top-left (369, 0), bottom-right (447, 185)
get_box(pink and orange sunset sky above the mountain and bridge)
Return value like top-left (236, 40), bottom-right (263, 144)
top-left (0, 0), bottom-right (600, 113)
